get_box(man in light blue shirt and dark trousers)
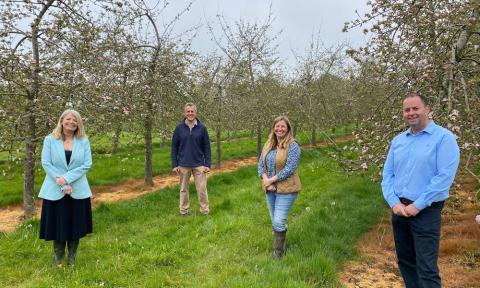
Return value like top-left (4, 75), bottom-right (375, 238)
top-left (382, 93), bottom-right (460, 288)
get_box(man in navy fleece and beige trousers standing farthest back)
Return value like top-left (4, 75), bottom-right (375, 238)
top-left (172, 103), bottom-right (211, 215)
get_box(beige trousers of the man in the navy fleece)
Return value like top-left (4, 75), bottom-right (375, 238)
top-left (179, 166), bottom-right (210, 214)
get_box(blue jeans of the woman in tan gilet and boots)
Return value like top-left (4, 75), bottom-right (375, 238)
top-left (266, 192), bottom-right (298, 232)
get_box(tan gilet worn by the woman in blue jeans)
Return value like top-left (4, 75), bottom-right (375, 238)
top-left (262, 139), bottom-right (302, 193)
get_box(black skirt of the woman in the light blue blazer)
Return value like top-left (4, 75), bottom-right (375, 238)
top-left (40, 195), bottom-right (93, 241)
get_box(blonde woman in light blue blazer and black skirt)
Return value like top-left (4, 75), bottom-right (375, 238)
top-left (38, 109), bottom-right (93, 266)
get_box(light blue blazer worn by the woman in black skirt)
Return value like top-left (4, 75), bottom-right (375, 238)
top-left (38, 135), bottom-right (92, 201)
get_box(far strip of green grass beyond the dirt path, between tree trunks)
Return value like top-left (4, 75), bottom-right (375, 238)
top-left (0, 130), bottom-right (343, 206)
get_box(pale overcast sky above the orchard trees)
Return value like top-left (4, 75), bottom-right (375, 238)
top-left (144, 0), bottom-right (368, 67)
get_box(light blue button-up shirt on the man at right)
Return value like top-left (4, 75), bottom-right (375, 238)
top-left (382, 121), bottom-right (460, 210)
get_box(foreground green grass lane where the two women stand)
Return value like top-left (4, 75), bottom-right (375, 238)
top-left (0, 150), bottom-right (385, 287)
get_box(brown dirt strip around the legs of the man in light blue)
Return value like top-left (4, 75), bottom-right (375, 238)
top-left (341, 175), bottom-right (480, 288)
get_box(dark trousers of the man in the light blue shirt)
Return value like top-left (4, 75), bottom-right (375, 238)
top-left (392, 201), bottom-right (444, 288)
